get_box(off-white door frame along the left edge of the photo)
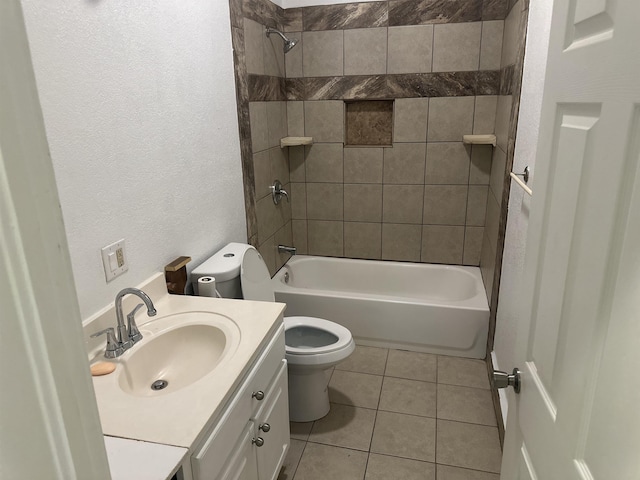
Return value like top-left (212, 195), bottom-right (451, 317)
top-left (0, 0), bottom-right (110, 479)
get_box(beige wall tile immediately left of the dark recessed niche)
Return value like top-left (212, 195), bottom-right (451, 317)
top-left (304, 100), bottom-right (344, 143)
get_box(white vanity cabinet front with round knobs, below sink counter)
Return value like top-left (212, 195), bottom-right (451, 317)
top-left (191, 326), bottom-right (289, 480)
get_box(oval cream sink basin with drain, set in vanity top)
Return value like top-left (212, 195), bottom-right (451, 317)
top-left (118, 319), bottom-right (237, 397)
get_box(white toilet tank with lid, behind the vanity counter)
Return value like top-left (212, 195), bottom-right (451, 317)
top-left (191, 242), bottom-right (252, 298)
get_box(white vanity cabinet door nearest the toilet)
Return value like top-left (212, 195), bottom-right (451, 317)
top-left (256, 360), bottom-right (289, 480)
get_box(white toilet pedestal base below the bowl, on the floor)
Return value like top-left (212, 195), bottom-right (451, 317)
top-left (288, 365), bottom-right (330, 422)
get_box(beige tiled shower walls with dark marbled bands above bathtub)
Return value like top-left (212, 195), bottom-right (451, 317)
top-left (230, 0), bottom-right (509, 272)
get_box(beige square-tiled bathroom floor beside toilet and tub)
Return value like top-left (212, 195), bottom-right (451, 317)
top-left (278, 346), bottom-right (502, 480)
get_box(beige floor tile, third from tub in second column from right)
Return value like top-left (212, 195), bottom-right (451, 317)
top-left (371, 412), bottom-right (436, 462)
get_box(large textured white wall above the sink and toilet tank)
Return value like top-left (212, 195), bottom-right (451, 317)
top-left (23, 0), bottom-right (246, 318)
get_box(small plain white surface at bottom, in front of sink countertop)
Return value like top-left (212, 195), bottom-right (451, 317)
top-left (104, 436), bottom-right (189, 480)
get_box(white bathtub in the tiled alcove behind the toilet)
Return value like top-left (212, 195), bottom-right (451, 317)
top-left (271, 255), bottom-right (489, 358)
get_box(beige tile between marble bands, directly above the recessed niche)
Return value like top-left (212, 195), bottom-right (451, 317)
top-left (344, 28), bottom-right (387, 75)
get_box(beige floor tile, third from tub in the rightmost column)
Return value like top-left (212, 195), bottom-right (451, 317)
top-left (436, 420), bottom-right (502, 473)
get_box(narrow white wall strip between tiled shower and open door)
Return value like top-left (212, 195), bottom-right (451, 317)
top-left (494, 0), bottom-right (552, 378)
